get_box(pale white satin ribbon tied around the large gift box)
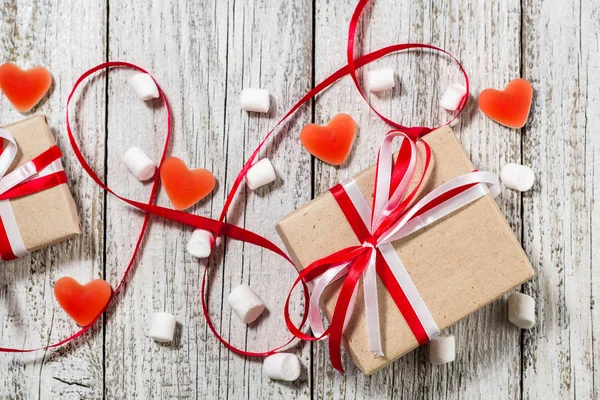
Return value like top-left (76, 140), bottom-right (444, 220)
top-left (309, 131), bottom-right (500, 356)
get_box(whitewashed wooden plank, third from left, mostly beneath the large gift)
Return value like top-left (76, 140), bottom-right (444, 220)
top-left (314, 1), bottom-right (521, 399)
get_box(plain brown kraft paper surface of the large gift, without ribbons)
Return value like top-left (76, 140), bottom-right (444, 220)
top-left (276, 127), bottom-right (534, 375)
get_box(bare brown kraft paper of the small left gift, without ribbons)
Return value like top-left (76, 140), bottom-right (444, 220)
top-left (0, 115), bottom-right (81, 260)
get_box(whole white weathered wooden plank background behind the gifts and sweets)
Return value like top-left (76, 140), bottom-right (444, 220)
top-left (0, 0), bottom-right (600, 399)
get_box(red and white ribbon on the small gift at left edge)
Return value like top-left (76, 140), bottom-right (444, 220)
top-left (0, 129), bottom-right (67, 261)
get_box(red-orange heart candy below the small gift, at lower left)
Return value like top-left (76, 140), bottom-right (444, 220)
top-left (54, 276), bottom-right (112, 326)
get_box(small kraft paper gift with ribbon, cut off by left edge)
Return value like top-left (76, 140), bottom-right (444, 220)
top-left (0, 115), bottom-right (81, 261)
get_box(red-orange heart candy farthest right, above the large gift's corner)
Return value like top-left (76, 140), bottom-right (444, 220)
top-left (479, 78), bottom-right (533, 129)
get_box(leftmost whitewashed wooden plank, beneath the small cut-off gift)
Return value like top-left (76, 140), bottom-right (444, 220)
top-left (0, 0), bottom-right (106, 399)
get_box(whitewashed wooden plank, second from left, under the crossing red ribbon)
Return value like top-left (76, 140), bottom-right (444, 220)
top-left (106, 1), bottom-right (312, 399)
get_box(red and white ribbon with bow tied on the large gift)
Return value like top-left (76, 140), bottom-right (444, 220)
top-left (285, 130), bottom-right (500, 369)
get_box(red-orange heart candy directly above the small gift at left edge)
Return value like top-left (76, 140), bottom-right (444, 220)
top-left (0, 63), bottom-right (52, 113)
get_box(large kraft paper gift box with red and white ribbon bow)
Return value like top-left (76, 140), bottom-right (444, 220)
top-left (277, 127), bottom-right (533, 375)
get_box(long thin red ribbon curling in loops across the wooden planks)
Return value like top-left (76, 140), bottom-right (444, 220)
top-left (0, 0), bottom-right (469, 369)
